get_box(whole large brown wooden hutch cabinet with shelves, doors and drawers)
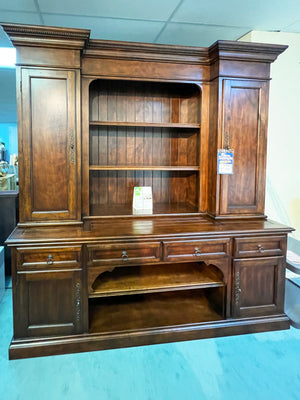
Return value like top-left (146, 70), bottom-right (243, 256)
top-left (2, 24), bottom-right (291, 358)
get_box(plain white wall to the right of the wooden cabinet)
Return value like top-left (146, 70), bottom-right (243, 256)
top-left (240, 31), bottom-right (300, 241)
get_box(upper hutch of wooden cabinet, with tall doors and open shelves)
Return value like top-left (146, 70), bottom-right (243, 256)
top-left (2, 24), bottom-right (286, 225)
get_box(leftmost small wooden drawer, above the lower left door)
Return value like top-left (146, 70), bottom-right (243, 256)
top-left (17, 246), bottom-right (81, 270)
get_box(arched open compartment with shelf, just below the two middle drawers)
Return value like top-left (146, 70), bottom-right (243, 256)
top-left (89, 263), bottom-right (224, 297)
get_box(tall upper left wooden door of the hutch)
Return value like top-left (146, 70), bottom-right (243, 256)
top-left (18, 68), bottom-right (78, 222)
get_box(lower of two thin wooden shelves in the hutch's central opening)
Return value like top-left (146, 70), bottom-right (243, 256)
top-left (89, 165), bottom-right (200, 171)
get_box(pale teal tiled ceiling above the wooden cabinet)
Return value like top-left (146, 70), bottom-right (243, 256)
top-left (0, 0), bottom-right (300, 122)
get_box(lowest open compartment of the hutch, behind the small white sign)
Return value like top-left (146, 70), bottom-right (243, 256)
top-left (89, 170), bottom-right (199, 215)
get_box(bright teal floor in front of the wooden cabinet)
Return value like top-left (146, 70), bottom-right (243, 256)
top-left (0, 289), bottom-right (300, 400)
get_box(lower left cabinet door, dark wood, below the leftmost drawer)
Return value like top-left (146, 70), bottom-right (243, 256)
top-left (14, 270), bottom-right (82, 338)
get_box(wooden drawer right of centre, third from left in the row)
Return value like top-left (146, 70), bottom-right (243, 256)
top-left (164, 239), bottom-right (230, 261)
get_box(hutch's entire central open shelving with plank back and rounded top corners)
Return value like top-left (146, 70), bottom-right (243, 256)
top-left (88, 79), bottom-right (201, 217)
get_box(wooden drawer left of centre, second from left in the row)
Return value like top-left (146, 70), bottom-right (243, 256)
top-left (87, 242), bottom-right (161, 266)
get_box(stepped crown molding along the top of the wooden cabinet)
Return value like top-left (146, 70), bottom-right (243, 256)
top-left (1, 23), bottom-right (288, 65)
